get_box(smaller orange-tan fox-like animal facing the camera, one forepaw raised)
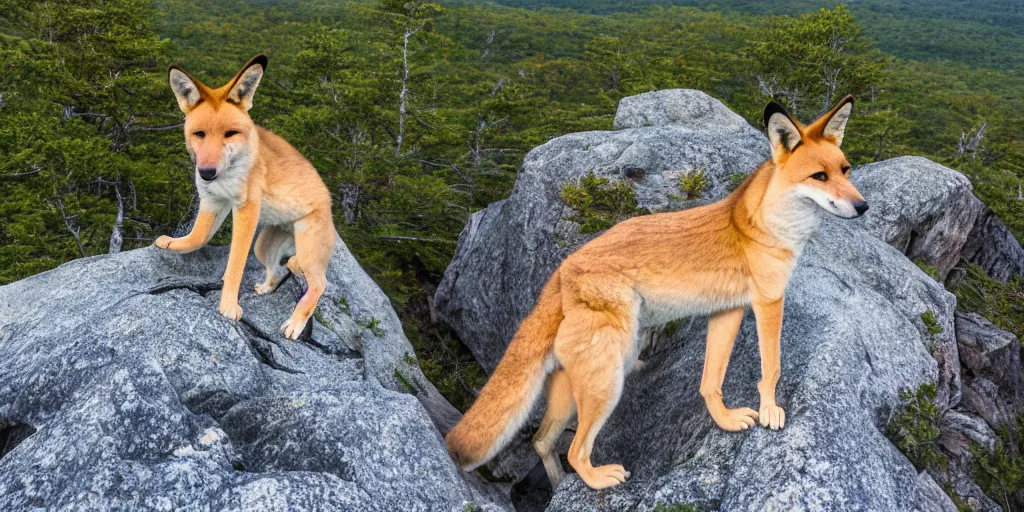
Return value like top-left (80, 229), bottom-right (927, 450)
top-left (155, 55), bottom-right (336, 339)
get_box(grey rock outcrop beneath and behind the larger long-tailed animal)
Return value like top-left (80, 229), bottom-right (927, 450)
top-left (435, 90), bottom-right (1024, 510)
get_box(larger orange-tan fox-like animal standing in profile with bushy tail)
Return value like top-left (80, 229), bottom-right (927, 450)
top-left (446, 97), bottom-right (866, 488)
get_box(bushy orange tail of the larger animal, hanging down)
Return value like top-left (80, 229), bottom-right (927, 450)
top-left (446, 272), bottom-right (563, 471)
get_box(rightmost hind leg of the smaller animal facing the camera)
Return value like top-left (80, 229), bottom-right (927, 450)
top-left (281, 210), bottom-right (335, 340)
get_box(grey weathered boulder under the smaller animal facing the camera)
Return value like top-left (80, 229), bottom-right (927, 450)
top-left (0, 239), bottom-right (508, 511)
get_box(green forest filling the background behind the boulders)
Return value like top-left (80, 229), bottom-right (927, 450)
top-left (0, 0), bottom-right (1024, 407)
